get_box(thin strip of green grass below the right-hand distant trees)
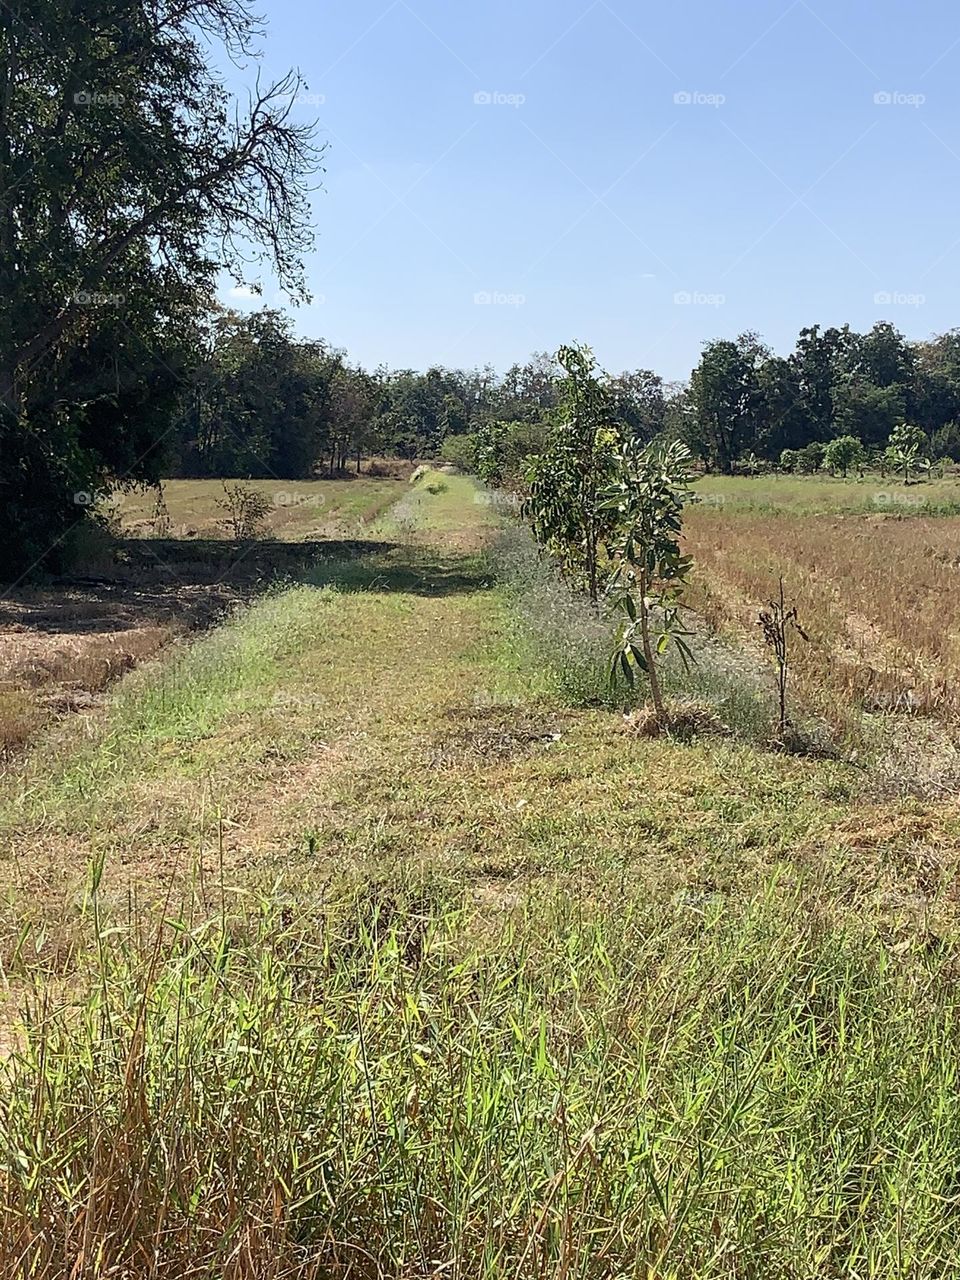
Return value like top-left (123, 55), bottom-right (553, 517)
top-left (694, 474), bottom-right (960, 516)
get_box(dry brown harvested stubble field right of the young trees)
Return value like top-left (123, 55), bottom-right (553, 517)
top-left (685, 507), bottom-right (960, 728)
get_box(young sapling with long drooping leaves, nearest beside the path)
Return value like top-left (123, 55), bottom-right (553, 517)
top-left (607, 442), bottom-right (691, 724)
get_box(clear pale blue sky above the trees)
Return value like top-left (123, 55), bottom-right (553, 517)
top-left (224, 0), bottom-right (960, 378)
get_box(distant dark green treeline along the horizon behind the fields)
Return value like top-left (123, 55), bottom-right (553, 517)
top-left (166, 310), bottom-right (960, 481)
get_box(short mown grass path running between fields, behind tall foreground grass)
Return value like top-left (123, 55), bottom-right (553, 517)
top-left (0, 477), bottom-right (960, 956)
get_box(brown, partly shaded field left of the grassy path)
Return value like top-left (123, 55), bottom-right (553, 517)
top-left (0, 476), bottom-right (412, 764)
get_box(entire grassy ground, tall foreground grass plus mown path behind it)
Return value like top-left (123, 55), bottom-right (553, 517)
top-left (0, 476), bottom-right (960, 1280)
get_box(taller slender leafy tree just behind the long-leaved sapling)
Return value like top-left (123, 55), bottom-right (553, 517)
top-left (524, 344), bottom-right (620, 604)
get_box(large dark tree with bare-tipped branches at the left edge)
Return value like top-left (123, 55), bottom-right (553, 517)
top-left (0, 0), bottom-right (319, 568)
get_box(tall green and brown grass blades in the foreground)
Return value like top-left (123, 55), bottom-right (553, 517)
top-left (0, 879), bottom-right (960, 1280)
